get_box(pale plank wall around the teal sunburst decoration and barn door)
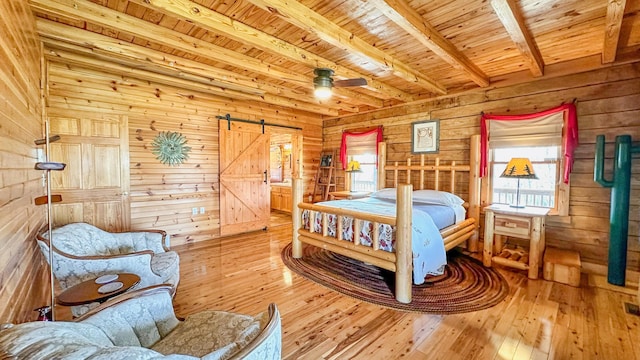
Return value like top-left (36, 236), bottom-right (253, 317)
top-left (47, 58), bottom-right (322, 245)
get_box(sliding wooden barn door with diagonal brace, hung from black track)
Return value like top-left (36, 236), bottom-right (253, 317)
top-left (219, 120), bottom-right (270, 235)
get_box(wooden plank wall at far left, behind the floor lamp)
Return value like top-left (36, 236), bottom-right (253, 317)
top-left (0, 0), bottom-right (49, 323)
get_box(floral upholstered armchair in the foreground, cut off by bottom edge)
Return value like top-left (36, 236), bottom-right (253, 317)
top-left (0, 285), bottom-right (282, 360)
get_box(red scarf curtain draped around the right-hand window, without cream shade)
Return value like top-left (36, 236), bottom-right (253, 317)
top-left (480, 104), bottom-right (578, 184)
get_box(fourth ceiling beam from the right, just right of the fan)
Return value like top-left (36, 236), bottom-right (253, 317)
top-left (244, 0), bottom-right (447, 94)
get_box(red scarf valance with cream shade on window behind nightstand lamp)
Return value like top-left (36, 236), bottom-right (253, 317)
top-left (480, 104), bottom-right (578, 184)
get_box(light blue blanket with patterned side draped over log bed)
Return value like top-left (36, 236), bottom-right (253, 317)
top-left (302, 198), bottom-right (447, 285)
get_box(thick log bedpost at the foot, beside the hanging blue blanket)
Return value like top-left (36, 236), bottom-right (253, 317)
top-left (396, 184), bottom-right (413, 304)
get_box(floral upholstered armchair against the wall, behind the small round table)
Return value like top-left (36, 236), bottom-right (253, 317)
top-left (37, 223), bottom-right (180, 316)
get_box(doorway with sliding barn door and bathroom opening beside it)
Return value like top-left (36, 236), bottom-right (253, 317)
top-left (218, 117), bottom-right (303, 236)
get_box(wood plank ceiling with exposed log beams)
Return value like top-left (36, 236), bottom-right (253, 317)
top-left (29, 0), bottom-right (640, 117)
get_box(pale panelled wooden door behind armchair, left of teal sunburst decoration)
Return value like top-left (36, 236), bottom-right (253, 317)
top-left (50, 115), bottom-right (131, 231)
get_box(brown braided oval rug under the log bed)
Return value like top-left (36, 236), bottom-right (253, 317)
top-left (282, 243), bottom-right (509, 314)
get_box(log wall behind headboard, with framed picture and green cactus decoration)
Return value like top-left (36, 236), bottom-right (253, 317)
top-left (323, 63), bottom-right (640, 273)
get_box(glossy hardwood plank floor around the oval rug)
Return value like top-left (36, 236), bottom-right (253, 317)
top-left (170, 225), bottom-right (640, 360)
